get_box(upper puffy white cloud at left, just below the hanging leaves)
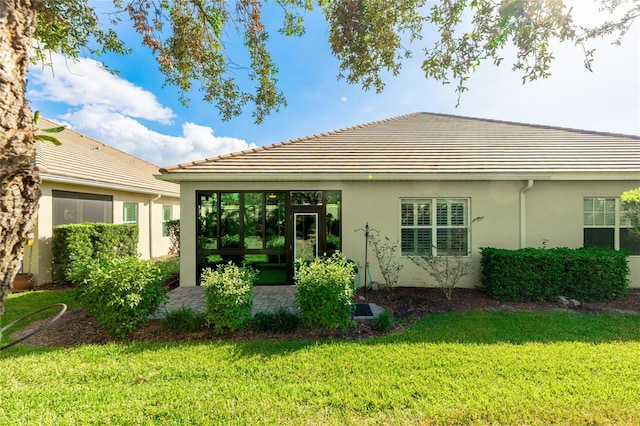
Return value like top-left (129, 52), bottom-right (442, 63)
top-left (27, 54), bottom-right (175, 124)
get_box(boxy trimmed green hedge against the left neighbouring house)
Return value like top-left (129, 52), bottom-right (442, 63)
top-left (52, 223), bottom-right (138, 281)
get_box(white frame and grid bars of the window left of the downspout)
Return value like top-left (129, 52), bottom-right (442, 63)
top-left (400, 197), bottom-right (471, 258)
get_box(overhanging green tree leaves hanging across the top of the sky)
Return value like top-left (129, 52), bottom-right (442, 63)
top-left (31, 0), bottom-right (640, 121)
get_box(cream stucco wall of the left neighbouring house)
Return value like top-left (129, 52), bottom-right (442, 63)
top-left (29, 181), bottom-right (180, 286)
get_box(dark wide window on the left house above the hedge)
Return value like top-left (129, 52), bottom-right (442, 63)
top-left (52, 190), bottom-right (113, 226)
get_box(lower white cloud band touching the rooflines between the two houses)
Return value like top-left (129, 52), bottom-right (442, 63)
top-left (60, 106), bottom-right (256, 166)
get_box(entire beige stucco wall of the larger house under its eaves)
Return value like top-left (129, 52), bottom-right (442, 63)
top-left (180, 177), bottom-right (640, 287)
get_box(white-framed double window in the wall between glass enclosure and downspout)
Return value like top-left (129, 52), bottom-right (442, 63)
top-left (400, 198), bottom-right (469, 256)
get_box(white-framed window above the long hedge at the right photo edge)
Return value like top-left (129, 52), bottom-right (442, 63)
top-left (583, 197), bottom-right (640, 255)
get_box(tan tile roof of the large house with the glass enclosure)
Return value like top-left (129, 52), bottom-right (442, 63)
top-left (160, 112), bottom-right (640, 181)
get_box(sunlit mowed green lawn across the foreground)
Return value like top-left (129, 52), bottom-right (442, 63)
top-left (0, 292), bottom-right (640, 425)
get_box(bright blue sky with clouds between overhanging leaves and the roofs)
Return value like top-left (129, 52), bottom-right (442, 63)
top-left (27, 0), bottom-right (640, 166)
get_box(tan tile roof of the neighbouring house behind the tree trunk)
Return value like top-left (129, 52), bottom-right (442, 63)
top-left (35, 119), bottom-right (180, 197)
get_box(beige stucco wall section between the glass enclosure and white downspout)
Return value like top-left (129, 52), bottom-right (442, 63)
top-left (343, 181), bottom-right (522, 287)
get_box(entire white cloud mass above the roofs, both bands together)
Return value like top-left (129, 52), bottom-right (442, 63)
top-left (27, 55), bottom-right (255, 166)
